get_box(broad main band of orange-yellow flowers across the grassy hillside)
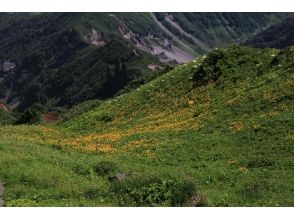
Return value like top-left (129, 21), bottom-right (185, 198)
top-left (0, 89), bottom-right (212, 159)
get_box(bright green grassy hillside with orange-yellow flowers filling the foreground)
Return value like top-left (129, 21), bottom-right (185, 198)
top-left (0, 46), bottom-right (294, 206)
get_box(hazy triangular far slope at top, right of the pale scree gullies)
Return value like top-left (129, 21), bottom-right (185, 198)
top-left (155, 13), bottom-right (287, 54)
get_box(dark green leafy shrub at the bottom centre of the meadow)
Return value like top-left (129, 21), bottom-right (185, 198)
top-left (112, 176), bottom-right (195, 206)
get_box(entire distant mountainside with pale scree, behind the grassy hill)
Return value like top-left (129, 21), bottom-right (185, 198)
top-left (0, 13), bottom-right (286, 110)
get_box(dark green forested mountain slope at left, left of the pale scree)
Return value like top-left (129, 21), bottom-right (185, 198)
top-left (0, 13), bottom-right (160, 110)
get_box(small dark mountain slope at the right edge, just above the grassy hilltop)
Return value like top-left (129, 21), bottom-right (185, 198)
top-left (244, 18), bottom-right (294, 48)
